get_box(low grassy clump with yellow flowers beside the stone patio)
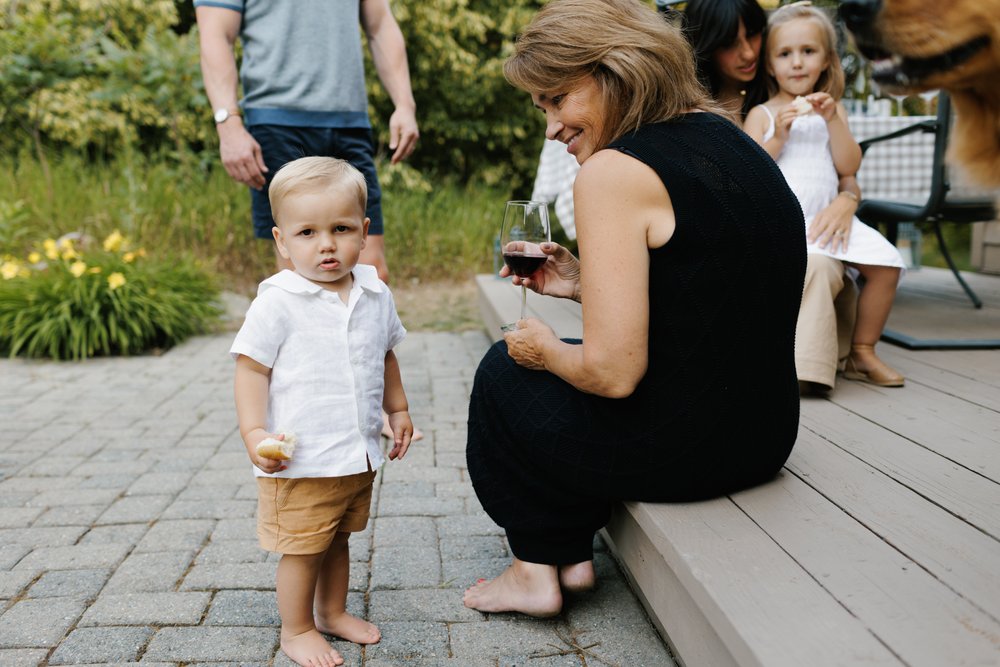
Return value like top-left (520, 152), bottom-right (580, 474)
top-left (0, 232), bottom-right (220, 359)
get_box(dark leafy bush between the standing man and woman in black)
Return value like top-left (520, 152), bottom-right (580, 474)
top-left (366, 0), bottom-right (544, 191)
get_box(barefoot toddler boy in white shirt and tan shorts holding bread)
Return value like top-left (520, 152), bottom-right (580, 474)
top-left (230, 157), bottom-right (413, 665)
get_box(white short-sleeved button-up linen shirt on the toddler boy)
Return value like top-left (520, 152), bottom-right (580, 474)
top-left (229, 264), bottom-right (406, 477)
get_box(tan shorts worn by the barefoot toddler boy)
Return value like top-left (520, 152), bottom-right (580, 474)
top-left (257, 471), bottom-right (375, 555)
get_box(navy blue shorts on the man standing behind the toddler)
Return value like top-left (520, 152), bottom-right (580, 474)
top-left (247, 125), bottom-right (382, 239)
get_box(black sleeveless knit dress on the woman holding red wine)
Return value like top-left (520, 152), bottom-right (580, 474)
top-left (467, 113), bottom-right (806, 565)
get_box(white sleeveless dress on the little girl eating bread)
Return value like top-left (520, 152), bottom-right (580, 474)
top-left (761, 104), bottom-right (906, 269)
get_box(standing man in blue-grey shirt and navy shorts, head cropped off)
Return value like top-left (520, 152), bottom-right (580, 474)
top-left (194, 0), bottom-right (420, 280)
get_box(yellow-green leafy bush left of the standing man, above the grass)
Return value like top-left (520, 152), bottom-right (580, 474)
top-left (0, 0), bottom-right (206, 160)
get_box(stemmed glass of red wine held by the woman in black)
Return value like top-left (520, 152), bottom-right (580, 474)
top-left (500, 201), bottom-right (551, 331)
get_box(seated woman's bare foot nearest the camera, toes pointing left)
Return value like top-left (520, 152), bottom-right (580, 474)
top-left (463, 558), bottom-right (562, 618)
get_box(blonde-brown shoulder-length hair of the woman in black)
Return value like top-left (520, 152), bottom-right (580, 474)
top-left (503, 0), bottom-right (730, 146)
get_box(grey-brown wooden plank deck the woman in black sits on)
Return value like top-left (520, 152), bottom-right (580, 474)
top-left (478, 268), bottom-right (1000, 667)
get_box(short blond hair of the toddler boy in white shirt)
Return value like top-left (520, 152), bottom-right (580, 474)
top-left (267, 156), bottom-right (368, 222)
